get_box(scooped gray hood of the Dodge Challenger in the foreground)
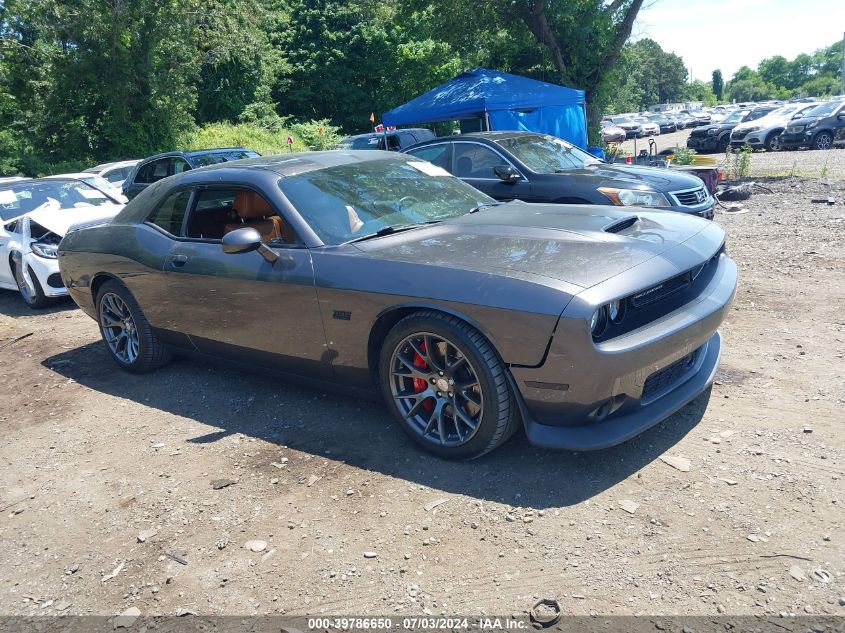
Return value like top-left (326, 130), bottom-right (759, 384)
top-left (356, 202), bottom-right (724, 288)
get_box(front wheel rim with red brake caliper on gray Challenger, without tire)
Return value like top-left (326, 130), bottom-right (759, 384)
top-left (390, 332), bottom-right (484, 447)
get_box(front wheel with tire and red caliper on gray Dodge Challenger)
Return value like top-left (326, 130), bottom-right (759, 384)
top-left (379, 310), bottom-right (520, 460)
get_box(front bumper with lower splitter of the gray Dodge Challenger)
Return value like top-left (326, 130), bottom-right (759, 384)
top-left (511, 244), bottom-right (737, 451)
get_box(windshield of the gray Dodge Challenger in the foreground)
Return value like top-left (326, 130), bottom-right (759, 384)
top-left (279, 159), bottom-right (493, 246)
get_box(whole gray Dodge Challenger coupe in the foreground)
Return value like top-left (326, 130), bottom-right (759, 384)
top-left (58, 151), bottom-right (737, 459)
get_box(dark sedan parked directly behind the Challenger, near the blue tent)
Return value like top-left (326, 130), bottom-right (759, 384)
top-left (406, 132), bottom-right (715, 218)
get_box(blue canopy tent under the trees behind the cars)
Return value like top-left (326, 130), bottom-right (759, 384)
top-left (382, 68), bottom-right (587, 147)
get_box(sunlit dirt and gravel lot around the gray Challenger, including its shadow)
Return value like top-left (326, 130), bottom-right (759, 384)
top-left (0, 173), bottom-right (845, 615)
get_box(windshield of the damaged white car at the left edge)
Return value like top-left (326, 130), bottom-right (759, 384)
top-left (0, 180), bottom-right (113, 222)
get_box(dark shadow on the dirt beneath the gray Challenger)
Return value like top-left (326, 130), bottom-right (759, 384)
top-left (42, 341), bottom-right (710, 509)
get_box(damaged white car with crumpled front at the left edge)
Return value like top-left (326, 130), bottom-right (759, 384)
top-left (0, 178), bottom-right (123, 308)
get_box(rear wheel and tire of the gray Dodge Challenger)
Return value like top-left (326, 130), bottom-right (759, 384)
top-left (95, 280), bottom-right (173, 374)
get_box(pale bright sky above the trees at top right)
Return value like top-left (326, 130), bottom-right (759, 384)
top-left (632, 0), bottom-right (845, 81)
